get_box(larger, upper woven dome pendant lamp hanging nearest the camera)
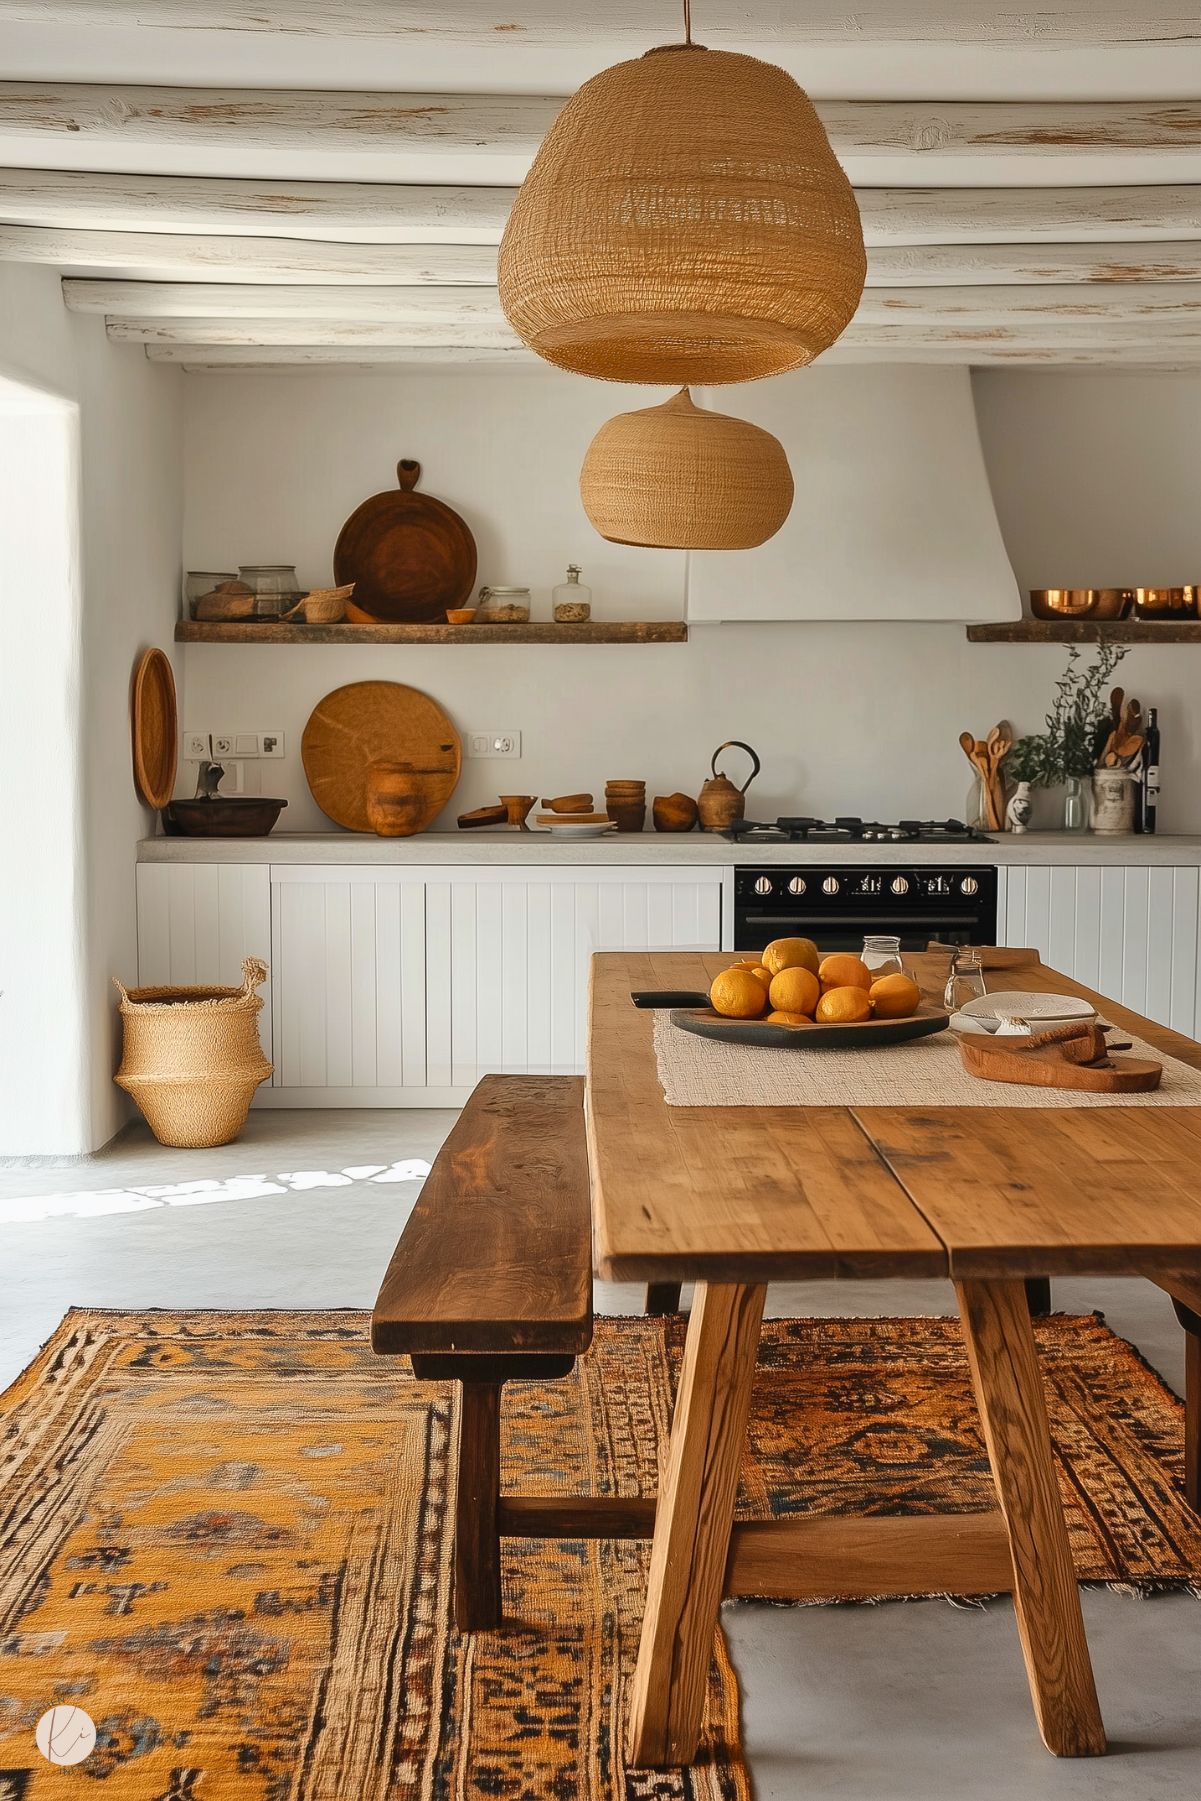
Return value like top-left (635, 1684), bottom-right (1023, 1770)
top-left (499, 7), bottom-right (866, 384)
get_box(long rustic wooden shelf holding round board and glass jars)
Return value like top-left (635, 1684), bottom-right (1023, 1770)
top-left (175, 620), bottom-right (688, 645)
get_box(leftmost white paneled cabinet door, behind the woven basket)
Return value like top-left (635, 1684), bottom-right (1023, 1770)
top-left (135, 863), bottom-right (274, 1058)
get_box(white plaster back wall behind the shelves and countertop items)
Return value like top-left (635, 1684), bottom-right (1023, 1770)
top-left (180, 373), bottom-right (1201, 832)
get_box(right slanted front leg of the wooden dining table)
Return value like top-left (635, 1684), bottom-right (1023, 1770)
top-left (956, 1281), bottom-right (1106, 1758)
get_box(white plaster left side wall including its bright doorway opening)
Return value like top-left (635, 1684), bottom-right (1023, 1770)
top-left (0, 265), bottom-right (182, 1158)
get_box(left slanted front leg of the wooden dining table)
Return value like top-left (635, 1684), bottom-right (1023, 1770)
top-left (630, 1282), bottom-right (767, 1767)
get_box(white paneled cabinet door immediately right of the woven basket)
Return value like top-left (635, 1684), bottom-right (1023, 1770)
top-left (272, 864), bottom-right (444, 1106)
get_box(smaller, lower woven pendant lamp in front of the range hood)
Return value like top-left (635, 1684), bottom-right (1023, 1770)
top-left (580, 389), bottom-right (792, 551)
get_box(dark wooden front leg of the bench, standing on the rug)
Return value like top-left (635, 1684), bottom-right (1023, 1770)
top-left (454, 1381), bottom-right (501, 1632)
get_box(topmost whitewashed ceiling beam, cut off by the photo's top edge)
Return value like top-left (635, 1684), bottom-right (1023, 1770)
top-left (0, 0), bottom-right (1201, 54)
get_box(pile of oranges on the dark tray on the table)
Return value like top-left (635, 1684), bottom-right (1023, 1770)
top-left (709, 938), bottom-right (922, 1027)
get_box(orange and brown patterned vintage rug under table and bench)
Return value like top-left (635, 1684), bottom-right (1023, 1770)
top-left (0, 1313), bottom-right (1201, 1801)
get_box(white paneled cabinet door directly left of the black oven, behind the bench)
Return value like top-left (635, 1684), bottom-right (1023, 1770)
top-left (444, 868), bottom-right (722, 1088)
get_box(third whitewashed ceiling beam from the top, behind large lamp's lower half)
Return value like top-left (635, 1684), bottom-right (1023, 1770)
top-left (9, 167), bottom-right (1201, 247)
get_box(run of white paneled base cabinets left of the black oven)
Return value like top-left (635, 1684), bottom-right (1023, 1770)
top-left (180, 864), bottom-right (722, 1106)
